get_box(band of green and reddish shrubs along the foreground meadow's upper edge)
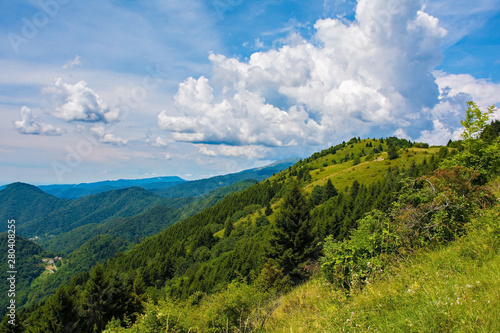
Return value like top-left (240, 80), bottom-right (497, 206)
top-left (322, 167), bottom-right (494, 289)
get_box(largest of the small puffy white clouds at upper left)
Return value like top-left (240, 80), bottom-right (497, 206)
top-left (43, 78), bottom-right (120, 123)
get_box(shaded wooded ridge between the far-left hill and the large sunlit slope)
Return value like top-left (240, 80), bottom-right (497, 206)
top-left (0, 180), bottom-right (264, 318)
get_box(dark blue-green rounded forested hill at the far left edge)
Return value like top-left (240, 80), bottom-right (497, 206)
top-left (0, 183), bottom-right (165, 240)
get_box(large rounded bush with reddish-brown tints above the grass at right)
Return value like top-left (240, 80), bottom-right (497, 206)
top-left (393, 167), bottom-right (494, 246)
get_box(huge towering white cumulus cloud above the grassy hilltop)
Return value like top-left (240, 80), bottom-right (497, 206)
top-left (158, 0), bottom-right (452, 149)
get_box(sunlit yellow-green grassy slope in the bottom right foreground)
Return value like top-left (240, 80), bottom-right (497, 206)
top-left (266, 185), bottom-right (500, 332)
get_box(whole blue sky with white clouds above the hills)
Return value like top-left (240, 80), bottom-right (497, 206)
top-left (0, 0), bottom-right (500, 184)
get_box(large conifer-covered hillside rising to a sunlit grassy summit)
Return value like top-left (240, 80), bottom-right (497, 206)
top-left (1, 138), bottom-right (446, 332)
